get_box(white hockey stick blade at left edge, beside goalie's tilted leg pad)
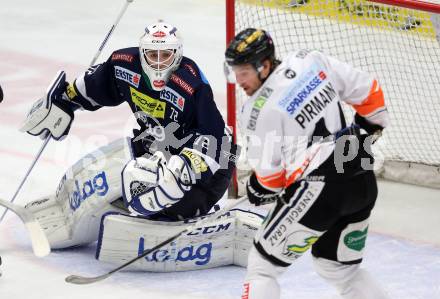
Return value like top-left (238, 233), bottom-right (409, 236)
top-left (0, 199), bottom-right (50, 257)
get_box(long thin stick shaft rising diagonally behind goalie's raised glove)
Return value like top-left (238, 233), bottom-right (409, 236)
top-left (0, 0), bottom-right (134, 222)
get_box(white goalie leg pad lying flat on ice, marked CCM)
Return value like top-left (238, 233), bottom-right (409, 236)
top-left (96, 211), bottom-right (262, 272)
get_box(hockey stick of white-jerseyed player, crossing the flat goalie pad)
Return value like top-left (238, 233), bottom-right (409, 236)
top-left (65, 196), bottom-right (247, 284)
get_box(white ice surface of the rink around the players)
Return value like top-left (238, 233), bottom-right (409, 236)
top-left (0, 0), bottom-right (440, 299)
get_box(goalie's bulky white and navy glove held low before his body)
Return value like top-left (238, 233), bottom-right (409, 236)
top-left (122, 151), bottom-right (195, 216)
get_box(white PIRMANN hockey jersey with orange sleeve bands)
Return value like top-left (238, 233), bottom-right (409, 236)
top-left (239, 50), bottom-right (388, 191)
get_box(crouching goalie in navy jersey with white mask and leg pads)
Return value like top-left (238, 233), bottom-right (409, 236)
top-left (22, 22), bottom-right (261, 271)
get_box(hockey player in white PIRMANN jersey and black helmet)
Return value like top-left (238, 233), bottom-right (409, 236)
top-left (225, 28), bottom-right (388, 299)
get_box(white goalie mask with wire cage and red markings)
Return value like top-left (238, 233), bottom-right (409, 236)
top-left (139, 22), bottom-right (183, 91)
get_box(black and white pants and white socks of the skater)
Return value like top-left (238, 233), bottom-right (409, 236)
top-left (242, 171), bottom-right (388, 299)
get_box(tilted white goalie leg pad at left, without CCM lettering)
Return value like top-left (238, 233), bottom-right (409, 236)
top-left (27, 139), bottom-right (131, 249)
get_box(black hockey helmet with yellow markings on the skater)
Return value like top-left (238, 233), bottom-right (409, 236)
top-left (225, 28), bottom-right (275, 68)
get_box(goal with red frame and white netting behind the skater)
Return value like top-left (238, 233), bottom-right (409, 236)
top-left (226, 0), bottom-right (440, 196)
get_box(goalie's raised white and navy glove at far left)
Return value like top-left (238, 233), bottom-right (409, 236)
top-left (20, 71), bottom-right (78, 140)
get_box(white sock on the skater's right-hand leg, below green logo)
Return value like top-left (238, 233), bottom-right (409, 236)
top-left (313, 257), bottom-right (389, 299)
